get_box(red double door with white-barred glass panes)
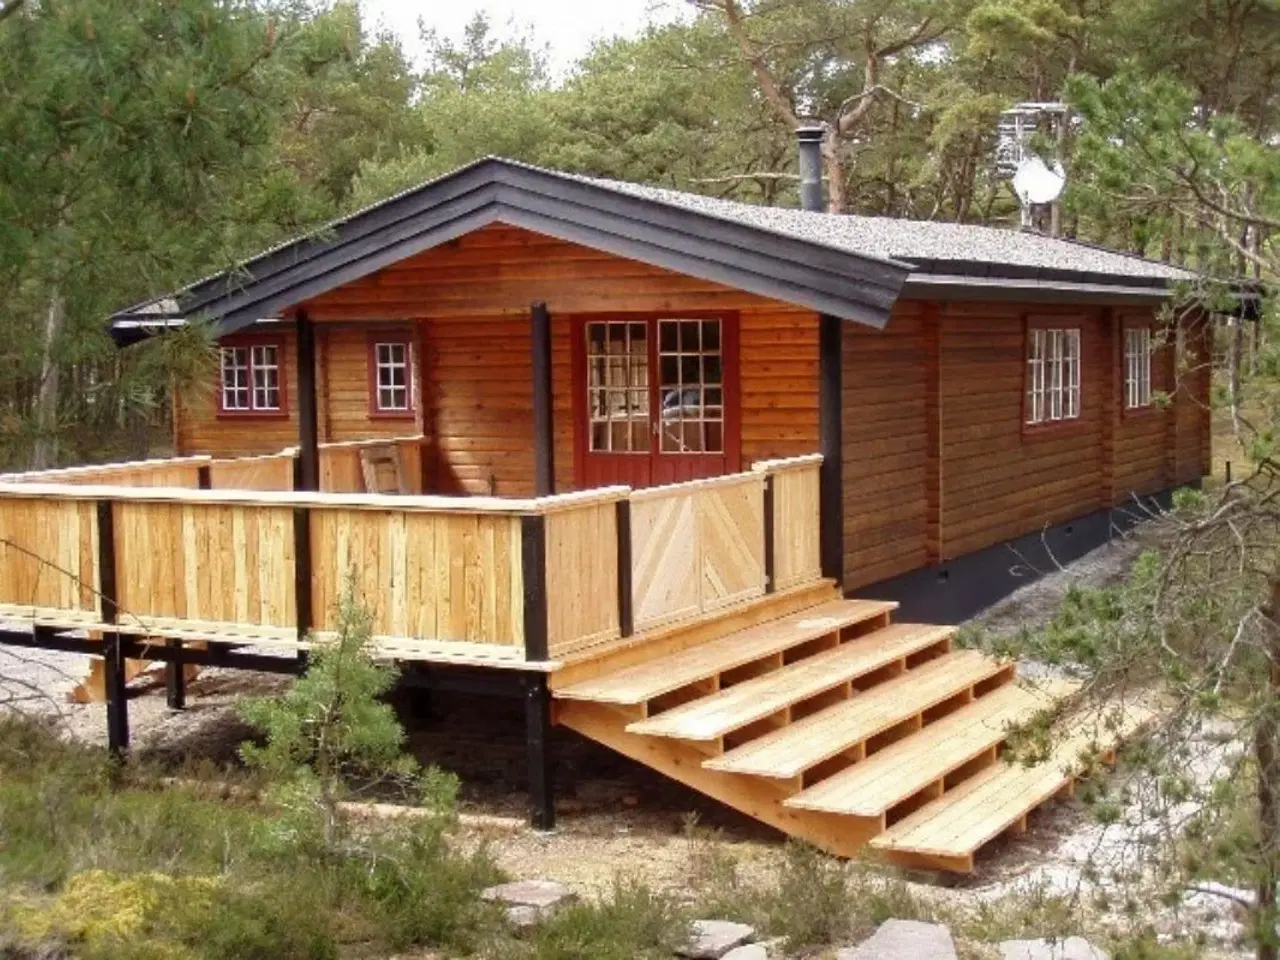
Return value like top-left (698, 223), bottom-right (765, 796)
top-left (573, 314), bottom-right (741, 489)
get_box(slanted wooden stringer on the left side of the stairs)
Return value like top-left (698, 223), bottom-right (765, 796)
top-left (554, 700), bottom-right (884, 856)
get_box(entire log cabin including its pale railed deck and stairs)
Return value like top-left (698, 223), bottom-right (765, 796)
top-left (0, 132), bottom-right (1210, 870)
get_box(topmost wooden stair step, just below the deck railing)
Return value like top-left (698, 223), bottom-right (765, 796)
top-left (556, 600), bottom-right (897, 704)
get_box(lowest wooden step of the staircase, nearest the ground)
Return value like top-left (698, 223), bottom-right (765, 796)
top-left (870, 705), bottom-right (1153, 872)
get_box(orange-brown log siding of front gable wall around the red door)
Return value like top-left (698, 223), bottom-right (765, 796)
top-left (296, 225), bottom-right (818, 495)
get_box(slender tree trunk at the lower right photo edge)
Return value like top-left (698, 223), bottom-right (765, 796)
top-left (1253, 577), bottom-right (1280, 960)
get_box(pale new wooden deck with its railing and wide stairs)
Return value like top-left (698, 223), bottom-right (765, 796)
top-left (0, 450), bottom-right (1148, 870)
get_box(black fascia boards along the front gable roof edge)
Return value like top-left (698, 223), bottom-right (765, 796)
top-left (113, 159), bottom-right (910, 333)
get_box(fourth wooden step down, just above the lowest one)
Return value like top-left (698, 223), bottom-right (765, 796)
top-left (786, 685), bottom-right (1053, 817)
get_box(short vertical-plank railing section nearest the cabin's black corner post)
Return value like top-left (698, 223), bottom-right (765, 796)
top-left (751, 453), bottom-right (822, 590)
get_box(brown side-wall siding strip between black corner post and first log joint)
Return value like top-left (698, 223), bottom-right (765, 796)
top-left (842, 302), bottom-right (928, 589)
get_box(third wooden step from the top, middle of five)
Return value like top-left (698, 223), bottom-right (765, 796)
top-left (703, 650), bottom-right (1012, 780)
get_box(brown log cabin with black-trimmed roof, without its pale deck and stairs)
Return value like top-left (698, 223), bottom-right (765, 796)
top-left (114, 134), bottom-right (1210, 621)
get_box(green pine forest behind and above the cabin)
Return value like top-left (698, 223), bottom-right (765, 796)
top-left (0, 0), bottom-right (1280, 468)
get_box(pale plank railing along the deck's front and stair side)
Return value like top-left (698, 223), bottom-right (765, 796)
top-left (0, 454), bottom-right (820, 662)
